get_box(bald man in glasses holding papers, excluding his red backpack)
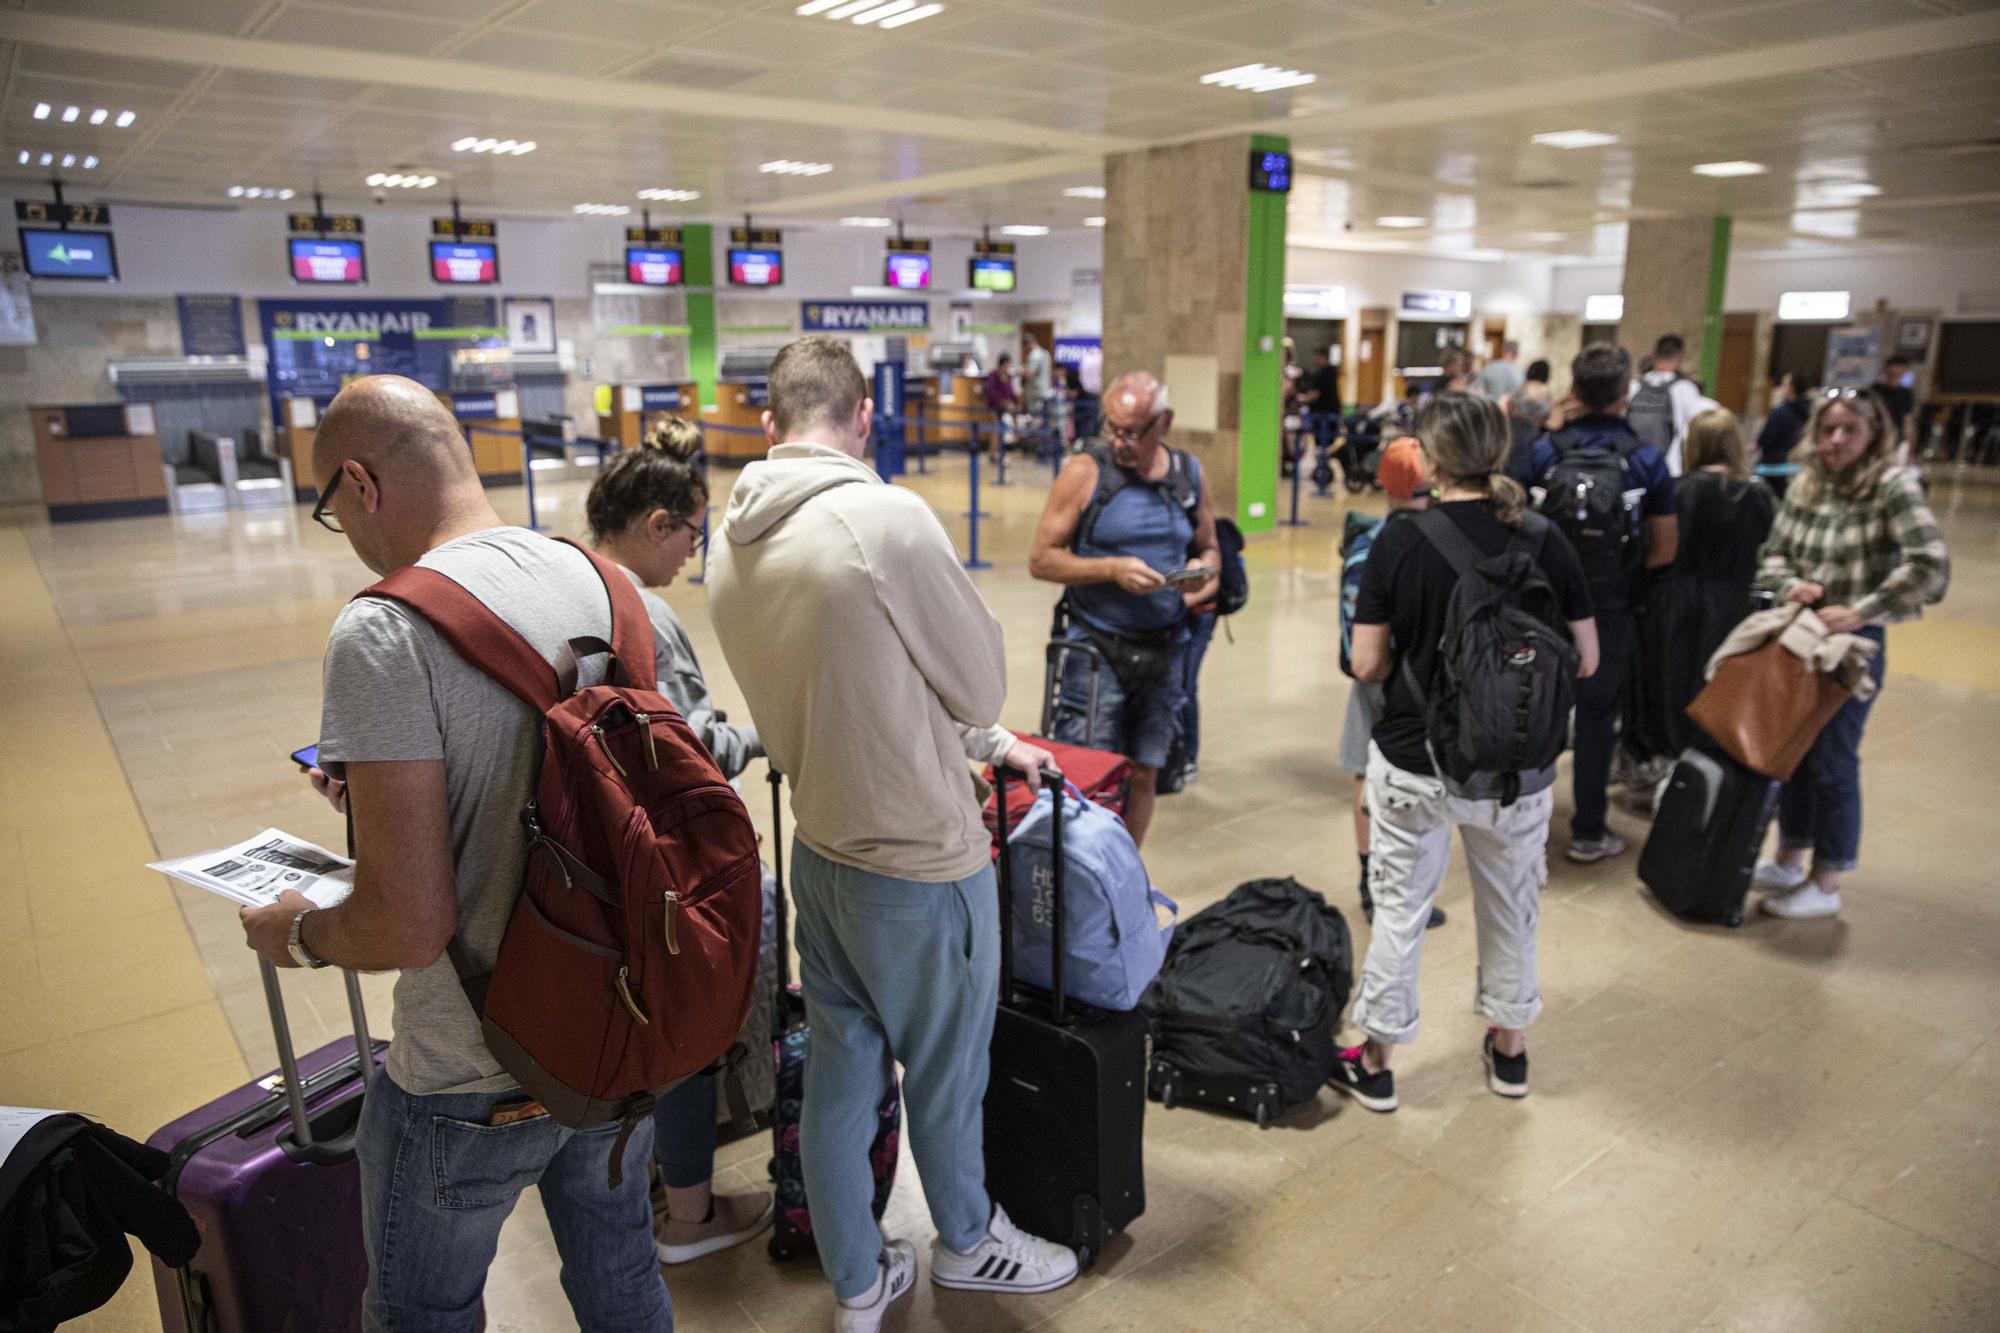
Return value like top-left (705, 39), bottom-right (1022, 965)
top-left (242, 374), bottom-right (674, 1333)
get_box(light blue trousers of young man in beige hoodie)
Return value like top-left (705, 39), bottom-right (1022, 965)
top-left (792, 841), bottom-right (1000, 1299)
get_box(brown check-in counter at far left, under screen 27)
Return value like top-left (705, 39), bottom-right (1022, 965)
top-left (28, 402), bottom-right (166, 522)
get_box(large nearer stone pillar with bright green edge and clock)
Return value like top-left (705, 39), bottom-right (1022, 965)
top-left (1104, 134), bottom-right (1286, 530)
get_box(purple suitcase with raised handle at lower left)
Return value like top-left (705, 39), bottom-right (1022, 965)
top-left (148, 961), bottom-right (384, 1333)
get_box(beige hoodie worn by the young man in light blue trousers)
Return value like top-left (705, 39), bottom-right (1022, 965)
top-left (708, 444), bottom-right (1006, 883)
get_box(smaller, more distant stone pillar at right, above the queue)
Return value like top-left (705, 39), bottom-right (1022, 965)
top-left (1618, 218), bottom-right (1730, 380)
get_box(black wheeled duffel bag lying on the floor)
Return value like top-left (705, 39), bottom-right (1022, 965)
top-left (1140, 879), bottom-right (1354, 1125)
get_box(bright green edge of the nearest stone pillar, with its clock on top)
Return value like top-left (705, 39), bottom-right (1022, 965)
top-left (1236, 134), bottom-right (1292, 532)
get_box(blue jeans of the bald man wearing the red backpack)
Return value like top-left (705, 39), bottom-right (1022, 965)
top-left (354, 1071), bottom-right (674, 1333)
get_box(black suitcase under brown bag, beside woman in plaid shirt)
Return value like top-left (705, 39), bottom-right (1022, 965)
top-left (1638, 747), bottom-right (1778, 927)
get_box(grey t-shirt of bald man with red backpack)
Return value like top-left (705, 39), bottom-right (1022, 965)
top-left (320, 528), bottom-right (668, 1095)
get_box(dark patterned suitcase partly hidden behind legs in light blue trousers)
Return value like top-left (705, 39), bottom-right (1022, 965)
top-left (766, 769), bottom-right (902, 1261)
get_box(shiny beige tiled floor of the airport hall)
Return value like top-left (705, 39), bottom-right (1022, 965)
top-left (0, 452), bottom-right (2000, 1333)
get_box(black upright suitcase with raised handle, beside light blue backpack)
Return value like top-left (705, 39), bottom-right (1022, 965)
top-left (986, 769), bottom-right (1150, 1269)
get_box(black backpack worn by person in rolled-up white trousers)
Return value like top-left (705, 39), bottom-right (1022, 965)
top-left (1402, 510), bottom-right (1578, 805)
